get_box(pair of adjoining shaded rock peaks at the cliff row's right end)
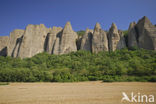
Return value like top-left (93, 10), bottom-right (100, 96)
top-left (128, 16), bottom-right (156, 50)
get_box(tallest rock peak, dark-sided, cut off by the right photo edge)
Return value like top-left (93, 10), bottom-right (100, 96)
top-left (136, 16), bottom-right (156, 50)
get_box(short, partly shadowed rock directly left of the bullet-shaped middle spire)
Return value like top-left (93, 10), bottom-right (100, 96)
top-left (80, 28), bottom-right (93, 51)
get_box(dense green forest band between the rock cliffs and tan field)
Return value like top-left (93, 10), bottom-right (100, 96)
top-left (0, 47), bottom-right (156, 82)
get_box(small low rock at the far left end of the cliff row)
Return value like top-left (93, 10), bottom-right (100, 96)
top-left (0, 36), bottom-right (9, 56)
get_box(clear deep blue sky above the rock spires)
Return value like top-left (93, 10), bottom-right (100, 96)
top-left (0, 0), bottom-right (156, 36)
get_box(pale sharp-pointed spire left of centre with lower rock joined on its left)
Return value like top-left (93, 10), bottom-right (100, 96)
top-left (49, 22), bottom-right (77, 55)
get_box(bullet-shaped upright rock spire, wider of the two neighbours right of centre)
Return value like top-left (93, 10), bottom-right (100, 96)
top-left (92, 23), bottom-right (108, 53)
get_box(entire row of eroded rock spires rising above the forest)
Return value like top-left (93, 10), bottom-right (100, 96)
top-left (0, 16), bottom-right (156, 58)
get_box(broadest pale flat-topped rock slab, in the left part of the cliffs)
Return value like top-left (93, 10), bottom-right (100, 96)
top-left (18, 24), bottom-right (49, 58)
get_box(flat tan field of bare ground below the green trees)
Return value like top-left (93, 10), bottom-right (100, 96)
top-left (0, 81), bottom-right (156, 104)
